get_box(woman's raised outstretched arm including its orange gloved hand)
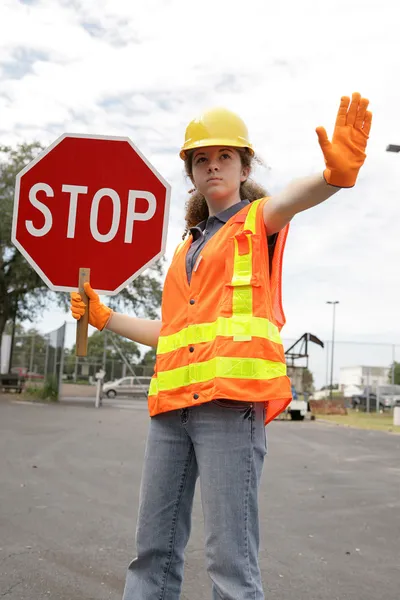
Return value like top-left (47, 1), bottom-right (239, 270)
top-left (263, 93), bottom-right (372, 235)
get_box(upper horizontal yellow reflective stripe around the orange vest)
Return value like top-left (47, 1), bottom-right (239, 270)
top-left (157, 314), bottom-right (282, 354)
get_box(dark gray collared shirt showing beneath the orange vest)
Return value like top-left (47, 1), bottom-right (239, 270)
top-left (186, 200), bottom-right (278, 283)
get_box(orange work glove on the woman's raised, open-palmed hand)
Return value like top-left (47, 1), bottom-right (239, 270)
top-left (316, 93), bottom-right (372, 187)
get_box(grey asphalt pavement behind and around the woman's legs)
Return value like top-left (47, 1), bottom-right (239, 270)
top-left (0, 396), bottom-right (400, 600)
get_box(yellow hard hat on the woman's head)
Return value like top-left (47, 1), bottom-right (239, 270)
top-left (179, 108), bottom-right (254, 160)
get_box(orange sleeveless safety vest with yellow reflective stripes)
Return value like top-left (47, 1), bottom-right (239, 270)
top-left (148, 198), bottom-right (292, 423)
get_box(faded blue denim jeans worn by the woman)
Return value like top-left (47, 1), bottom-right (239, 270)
top-left (123, 400), bottom-right (267, 600)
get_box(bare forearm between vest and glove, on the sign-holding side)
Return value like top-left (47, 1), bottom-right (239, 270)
top-left (106, 312), bottom-right (161, 348)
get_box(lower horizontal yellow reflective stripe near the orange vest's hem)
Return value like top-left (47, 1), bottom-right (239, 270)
top-left (149, 356), bottom-right (286, 396)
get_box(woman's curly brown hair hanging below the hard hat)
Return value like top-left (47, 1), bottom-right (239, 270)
top-left (182, 148), bottom-right (268, 239)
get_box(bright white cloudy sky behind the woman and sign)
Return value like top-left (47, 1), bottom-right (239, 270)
top-left (0, 0), bottom-right (400, 385)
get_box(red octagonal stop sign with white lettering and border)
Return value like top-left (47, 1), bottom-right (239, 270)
top-left (12, 134), bottom-right (170, 295)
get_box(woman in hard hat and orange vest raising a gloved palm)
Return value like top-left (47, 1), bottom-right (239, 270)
top-left (71, 94), bottom-right (372, 600)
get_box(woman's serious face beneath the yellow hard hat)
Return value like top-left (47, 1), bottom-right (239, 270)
top-left (192, 146), bottom-right (249, 201)
